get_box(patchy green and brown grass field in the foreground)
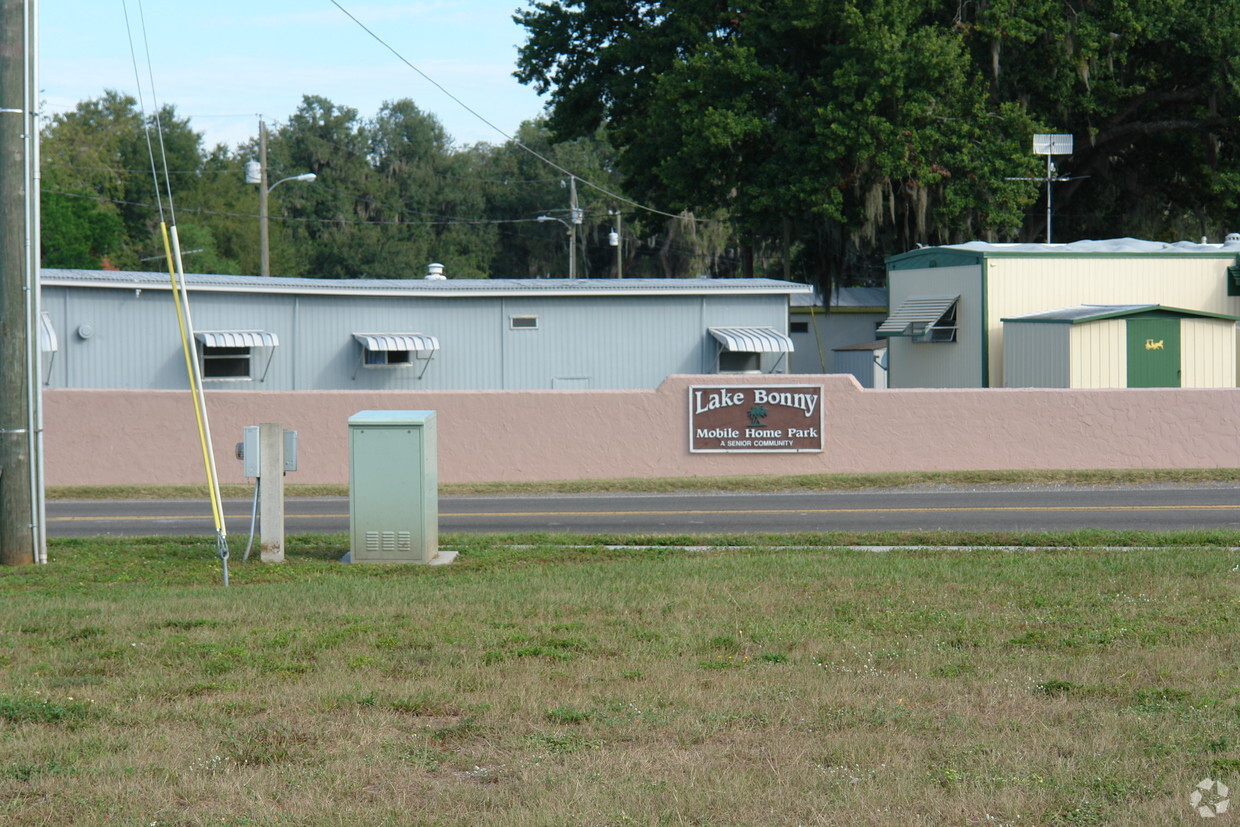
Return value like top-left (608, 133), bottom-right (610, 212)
top-left (0, 534), bottom-right (1240, 826)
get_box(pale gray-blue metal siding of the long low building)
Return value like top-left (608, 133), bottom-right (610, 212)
top-left (43, 285), bottom-right (787, 391)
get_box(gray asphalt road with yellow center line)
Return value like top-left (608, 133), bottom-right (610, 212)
top-left (47, 485), bottom-right (1240, 537)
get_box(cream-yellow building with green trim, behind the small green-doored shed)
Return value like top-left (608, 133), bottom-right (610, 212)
top-left (878, 236), bottom-right (1240, 388)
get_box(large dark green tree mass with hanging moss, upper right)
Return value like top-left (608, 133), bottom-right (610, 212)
top-left (516, 0), bottom-right (1240, 286)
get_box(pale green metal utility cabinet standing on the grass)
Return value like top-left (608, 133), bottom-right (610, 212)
top-left (348, 410), bottom-right (439, 564)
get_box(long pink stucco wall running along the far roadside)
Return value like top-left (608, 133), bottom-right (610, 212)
top-left (43, 376), bottom-right (1240, 485)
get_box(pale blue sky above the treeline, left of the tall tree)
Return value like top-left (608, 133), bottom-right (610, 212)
top-left (38, 0), bottom-right (543, 148)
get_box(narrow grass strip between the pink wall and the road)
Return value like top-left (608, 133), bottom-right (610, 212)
top-left (46, 469), bottom-right (1240, 500)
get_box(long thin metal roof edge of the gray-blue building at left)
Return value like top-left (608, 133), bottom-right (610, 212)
top-left (42, 269), bottom-right (813, 298)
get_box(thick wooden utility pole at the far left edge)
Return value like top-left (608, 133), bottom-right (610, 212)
top-left (0, 0), bottom-right (38, 565)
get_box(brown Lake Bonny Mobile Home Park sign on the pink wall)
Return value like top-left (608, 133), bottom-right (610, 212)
top-left (689, 384), bottom-right (822, 454)
